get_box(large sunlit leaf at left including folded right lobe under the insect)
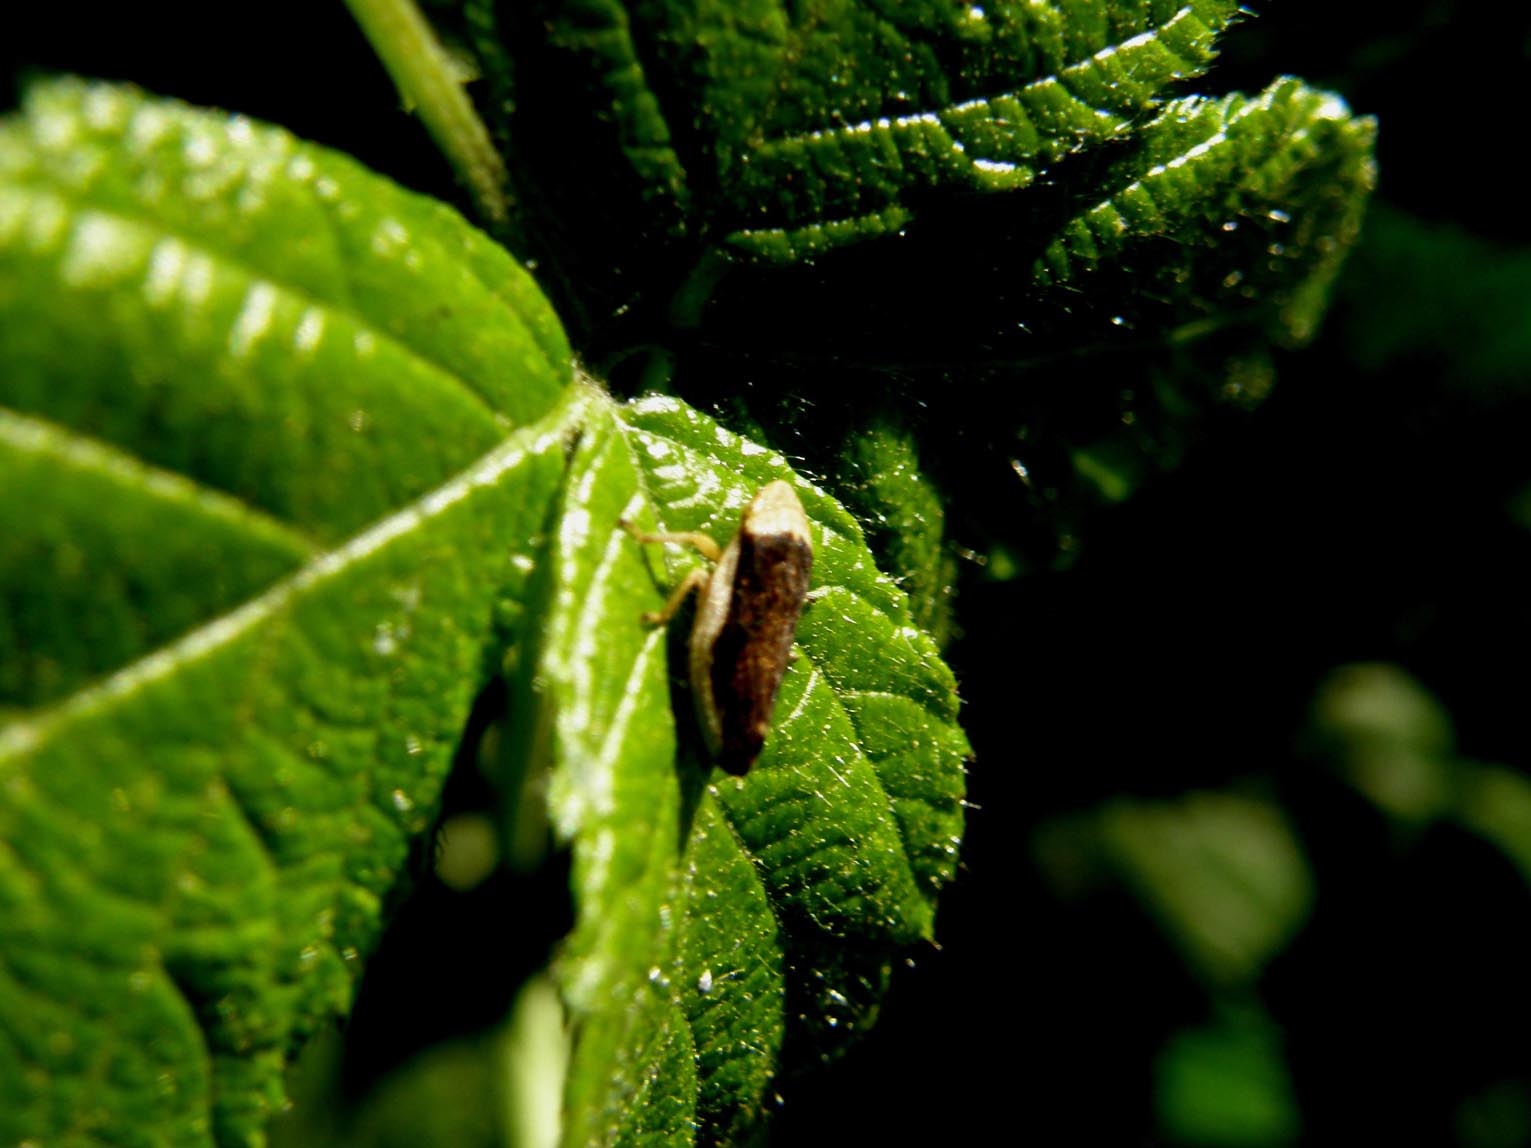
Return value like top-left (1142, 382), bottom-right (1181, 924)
top-left (0, 74), bottom-right (968, 1143)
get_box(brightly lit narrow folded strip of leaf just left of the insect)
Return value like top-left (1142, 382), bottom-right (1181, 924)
top-left (511, 404), bottom-right (680, 1143)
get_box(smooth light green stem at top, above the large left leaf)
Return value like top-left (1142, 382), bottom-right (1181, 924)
top-left (346, 0), bottom-right (510, 223)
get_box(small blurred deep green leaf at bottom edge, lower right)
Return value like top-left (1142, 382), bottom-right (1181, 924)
top-left (1154, 1012), bottom-right (1301, 1148)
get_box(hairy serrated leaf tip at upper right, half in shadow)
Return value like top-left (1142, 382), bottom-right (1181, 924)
top-left (1033, 78), bottom-right (1375, 343)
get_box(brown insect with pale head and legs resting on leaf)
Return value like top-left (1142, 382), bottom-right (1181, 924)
top-left (629, 481), bottom-right (813, 775)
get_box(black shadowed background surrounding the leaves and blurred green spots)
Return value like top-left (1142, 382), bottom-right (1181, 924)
top-left (11, 0), bottom-right (1531, 1145)
